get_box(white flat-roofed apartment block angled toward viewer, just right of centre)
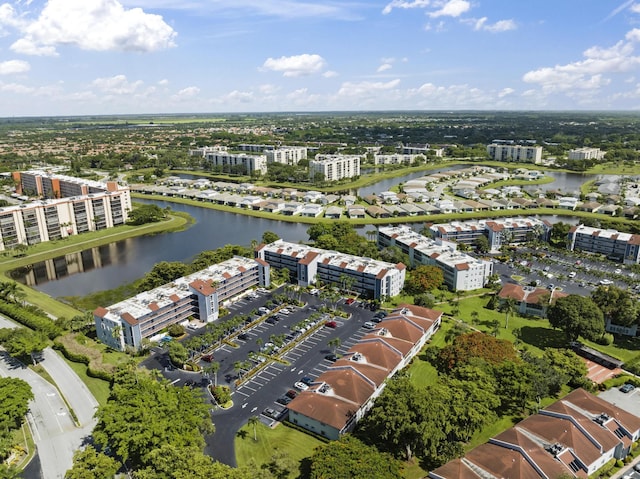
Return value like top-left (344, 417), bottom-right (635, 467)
top-left (378, 226), bottom-right (493, 291)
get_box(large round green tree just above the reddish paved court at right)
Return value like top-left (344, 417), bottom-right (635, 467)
top-left (547, 294), bottom-right (604, 342)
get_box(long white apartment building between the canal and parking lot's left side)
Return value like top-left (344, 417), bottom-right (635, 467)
top-left (93, 256), bottom-right (270, 351)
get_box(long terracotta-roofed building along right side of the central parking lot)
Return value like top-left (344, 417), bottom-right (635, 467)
top-left (287, 305), bottom-right (442, 440)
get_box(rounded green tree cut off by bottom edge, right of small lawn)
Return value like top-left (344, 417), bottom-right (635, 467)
top-left (310, 435), bottom-right (401, 479)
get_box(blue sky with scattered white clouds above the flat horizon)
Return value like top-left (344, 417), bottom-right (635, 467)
top-left (0, 0), bottom-right (640, 117)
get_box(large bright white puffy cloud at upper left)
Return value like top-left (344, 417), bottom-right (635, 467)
top-left (11, 0), bottom-right (176, 55)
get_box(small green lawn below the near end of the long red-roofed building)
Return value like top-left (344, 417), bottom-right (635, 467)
top-left (235, 423), bottom-right (324, 478)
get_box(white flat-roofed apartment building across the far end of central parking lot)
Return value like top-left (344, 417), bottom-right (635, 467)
top-left (256, 239), bottom-right (406, 299)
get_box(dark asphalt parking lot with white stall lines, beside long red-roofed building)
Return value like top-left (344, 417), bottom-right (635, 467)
top-left (144, 291), bottom-right (382, 464)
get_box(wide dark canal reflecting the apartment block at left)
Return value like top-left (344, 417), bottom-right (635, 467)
top-left (13, 199), bottom-right (309, 297)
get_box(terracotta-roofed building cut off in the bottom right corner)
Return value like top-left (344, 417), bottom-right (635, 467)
top-left (428, 389), bottom-right (640, 479)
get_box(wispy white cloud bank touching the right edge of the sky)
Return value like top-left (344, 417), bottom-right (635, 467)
top-left (522, 37), bottom-right (640, 92)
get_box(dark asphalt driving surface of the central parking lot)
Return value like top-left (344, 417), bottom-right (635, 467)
top-left (143, 294), bottom-right (374, 466)
